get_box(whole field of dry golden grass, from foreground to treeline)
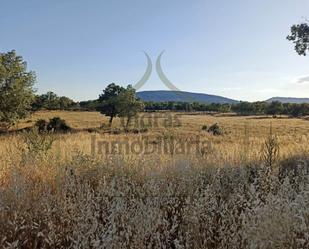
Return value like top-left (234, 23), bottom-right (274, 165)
top-left (0, 112), bottom-right (309, 248)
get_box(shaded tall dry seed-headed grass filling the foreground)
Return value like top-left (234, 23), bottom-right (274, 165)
top-left (0, 154), bottom-right (309, 249)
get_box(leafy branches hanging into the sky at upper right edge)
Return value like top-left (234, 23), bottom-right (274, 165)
top-left (287, 23), bottom-right (309, 56)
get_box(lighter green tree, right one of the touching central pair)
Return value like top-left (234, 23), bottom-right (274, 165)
top-left (118, 85), bottom-right (144, 129)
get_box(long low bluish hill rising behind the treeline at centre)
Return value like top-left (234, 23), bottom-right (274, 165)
top-left (137, 90), bottom-right (239, 104)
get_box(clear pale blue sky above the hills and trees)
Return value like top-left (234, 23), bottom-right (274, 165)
top-left (0, 0), bottom-right (309, 101)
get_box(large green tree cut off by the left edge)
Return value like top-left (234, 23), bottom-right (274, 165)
top-left (0, 50), bottom-right (36, 128)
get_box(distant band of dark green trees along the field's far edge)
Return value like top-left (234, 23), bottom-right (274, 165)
top-left (32, 88), bottom-right (309, 117)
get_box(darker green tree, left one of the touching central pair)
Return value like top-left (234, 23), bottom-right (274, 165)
top-left (96, 83), bottom-right (125, 126)
